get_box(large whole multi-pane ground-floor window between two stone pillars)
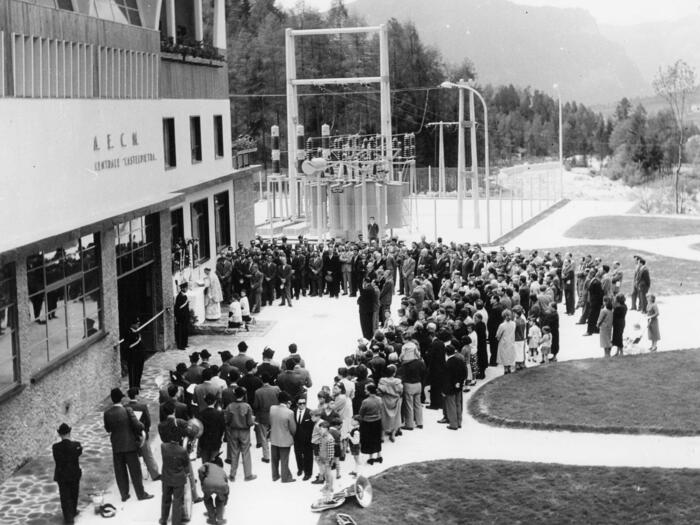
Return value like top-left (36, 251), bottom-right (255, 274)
top-left (27, 234), bottom-right (102, 371)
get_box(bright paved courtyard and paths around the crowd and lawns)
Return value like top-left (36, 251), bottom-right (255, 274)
top-left (0, 201), bottom-right (700, 525)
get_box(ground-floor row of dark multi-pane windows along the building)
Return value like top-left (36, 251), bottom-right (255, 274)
top-left (0, 191), bottom-right (231, 392)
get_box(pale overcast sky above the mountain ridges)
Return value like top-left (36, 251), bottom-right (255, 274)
top-left (277, 0), bottom-right (700, 25)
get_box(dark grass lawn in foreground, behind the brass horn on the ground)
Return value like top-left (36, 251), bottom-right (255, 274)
top-left (318, 459), bottom-right (700, 525)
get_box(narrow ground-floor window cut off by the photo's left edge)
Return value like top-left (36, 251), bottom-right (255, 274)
top-left (0, 263), bottom-right (20, 392)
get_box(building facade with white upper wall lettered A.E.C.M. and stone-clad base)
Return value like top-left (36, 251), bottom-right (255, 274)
top-left (0, 0), bottom-right (256, 480)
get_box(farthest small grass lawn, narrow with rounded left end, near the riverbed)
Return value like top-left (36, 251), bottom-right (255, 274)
top-left (564, 215), bottom-right (700, 239)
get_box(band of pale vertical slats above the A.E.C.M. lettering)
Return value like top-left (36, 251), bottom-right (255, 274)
top-left (11, 33), bottom-right (159, 99)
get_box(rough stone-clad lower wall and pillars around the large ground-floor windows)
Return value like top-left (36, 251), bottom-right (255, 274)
top-left (0, 228), bottom-right (120, 482)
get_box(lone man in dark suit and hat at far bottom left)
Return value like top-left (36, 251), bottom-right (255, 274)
top-left (53, 423), bottom-right (83, 523)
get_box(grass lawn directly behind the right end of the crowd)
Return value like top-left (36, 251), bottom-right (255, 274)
top-left (539, 246), bottom-right (700, 294)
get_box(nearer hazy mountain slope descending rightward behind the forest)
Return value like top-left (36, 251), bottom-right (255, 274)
top-left (348, 0), bottom-right (651, 104)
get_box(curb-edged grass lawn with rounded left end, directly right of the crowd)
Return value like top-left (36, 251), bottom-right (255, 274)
top-left (468, 348), bottom-right (700, 435)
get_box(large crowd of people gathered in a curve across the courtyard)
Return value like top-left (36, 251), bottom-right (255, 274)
top-left (52, 233), bottom-right (659, 524)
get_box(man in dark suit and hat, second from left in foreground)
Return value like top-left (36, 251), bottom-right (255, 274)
top-left (104, 388), bottom-right (153, 501)
